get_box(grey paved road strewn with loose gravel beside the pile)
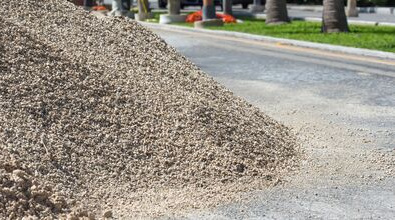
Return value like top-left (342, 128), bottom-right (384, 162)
top-left (148, 27), bottom-right (395, 219)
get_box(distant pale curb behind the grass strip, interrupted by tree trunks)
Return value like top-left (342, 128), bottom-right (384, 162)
top-left (234, 12), bottom-right (395, 27)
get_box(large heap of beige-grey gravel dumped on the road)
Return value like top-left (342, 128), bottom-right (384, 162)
top-left (0, 0), bottom-right (297, 218)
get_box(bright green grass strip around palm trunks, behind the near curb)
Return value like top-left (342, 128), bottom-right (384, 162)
top-left (149, 14), bottom-right (395, 52)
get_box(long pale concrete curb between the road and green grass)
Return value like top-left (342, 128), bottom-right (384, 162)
top-left (139, 22), bottom-right (395, 60)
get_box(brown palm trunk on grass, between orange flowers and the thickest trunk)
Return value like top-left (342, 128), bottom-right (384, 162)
top-left (266, 0), bottom-right (290, 24)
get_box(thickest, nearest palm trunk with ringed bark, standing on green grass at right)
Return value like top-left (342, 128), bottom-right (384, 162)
top-left (322, 0), bottom-right (349, 33)
